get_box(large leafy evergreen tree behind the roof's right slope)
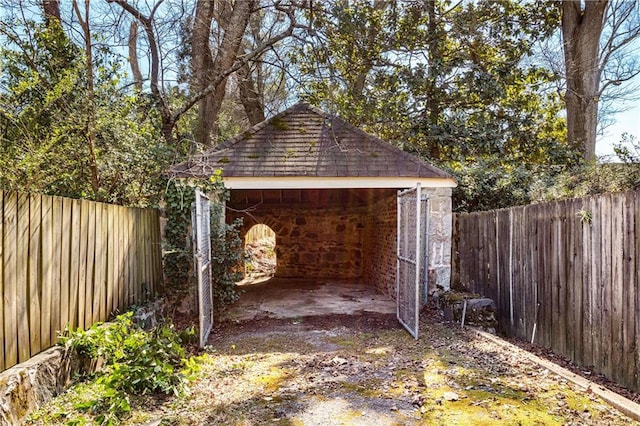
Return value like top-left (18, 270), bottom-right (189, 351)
top-left (298, 0), bottom-right (566, 164)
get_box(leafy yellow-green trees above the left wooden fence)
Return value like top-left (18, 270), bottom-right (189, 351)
top-left (0, 2), bottom-right (171, 206)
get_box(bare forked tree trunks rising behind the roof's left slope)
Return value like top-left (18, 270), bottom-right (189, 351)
top-left (107, 0), bottom-right (301, 146)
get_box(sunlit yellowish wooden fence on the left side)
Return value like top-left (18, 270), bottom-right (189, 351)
top-left (0, 191), bottom-right (162, 371)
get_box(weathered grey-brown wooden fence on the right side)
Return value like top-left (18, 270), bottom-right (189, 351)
top-left (454, 192), bottom-right (640, 391)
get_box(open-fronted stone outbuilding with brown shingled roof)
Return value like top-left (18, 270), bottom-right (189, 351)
top-left (172, 103), bottom-right (456, 336)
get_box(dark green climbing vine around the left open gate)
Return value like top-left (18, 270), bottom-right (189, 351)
top-left (164, 173), bottom-right (243, 313)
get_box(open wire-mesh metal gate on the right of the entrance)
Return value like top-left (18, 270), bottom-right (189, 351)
top-left (396, 184), bottom-right (429, 339)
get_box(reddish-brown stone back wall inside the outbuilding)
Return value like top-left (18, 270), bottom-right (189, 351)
top-left (229, 205), bottom-right (365, 279)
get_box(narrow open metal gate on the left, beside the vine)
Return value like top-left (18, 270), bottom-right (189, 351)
top-left (191, 188), bottom-right (213, 348)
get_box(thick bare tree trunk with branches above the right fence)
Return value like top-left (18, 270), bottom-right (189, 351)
top-left (560, 0), bottom-right (640, 160)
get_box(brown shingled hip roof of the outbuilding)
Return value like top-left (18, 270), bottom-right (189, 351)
top-left (170, 103), bottom-right (451, 179)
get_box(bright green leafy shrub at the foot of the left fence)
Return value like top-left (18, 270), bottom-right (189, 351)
top-left (30, 312), bottom-right (198, 425)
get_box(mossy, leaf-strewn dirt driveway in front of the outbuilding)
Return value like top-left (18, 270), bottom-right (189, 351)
top-left (131, 313), bottom-right (632, 426)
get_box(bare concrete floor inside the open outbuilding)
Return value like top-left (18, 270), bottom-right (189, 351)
top-left (225, 278), bottom-right (396, 321)
